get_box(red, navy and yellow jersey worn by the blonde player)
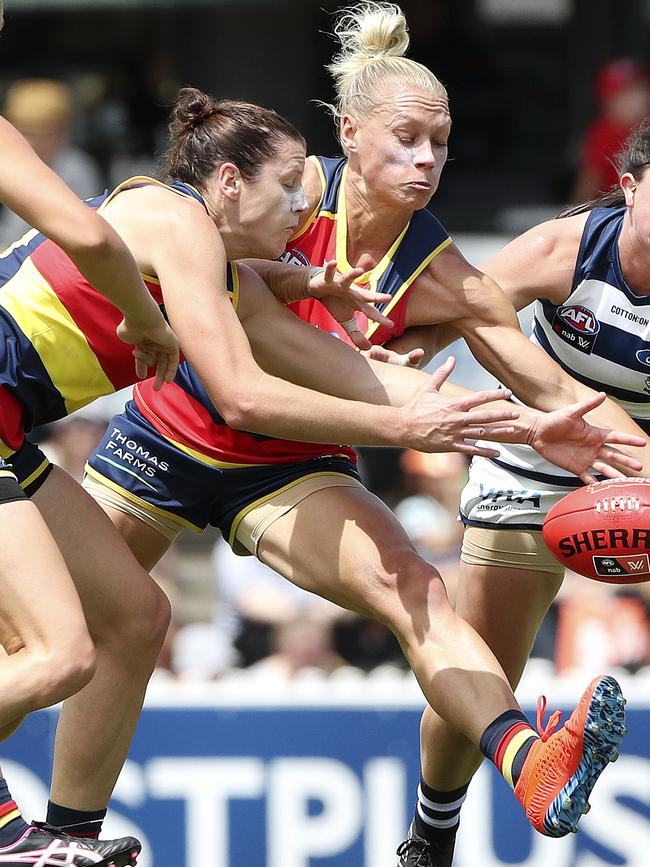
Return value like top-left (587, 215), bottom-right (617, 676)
top-left (134, 157), bottom-right (452, 468)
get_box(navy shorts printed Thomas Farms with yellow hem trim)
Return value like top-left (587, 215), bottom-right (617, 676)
top-left (86, 401), bottom-right (359, 553)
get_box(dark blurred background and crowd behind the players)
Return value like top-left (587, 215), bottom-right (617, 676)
top-left (0, 0), bottom-right (650, 680)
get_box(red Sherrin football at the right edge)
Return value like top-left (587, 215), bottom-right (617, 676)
top-left (542, 478), bottom-right (650, 584)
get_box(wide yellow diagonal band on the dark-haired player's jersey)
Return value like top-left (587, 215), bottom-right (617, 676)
top-left (0, 258), bottom-right (115, 413)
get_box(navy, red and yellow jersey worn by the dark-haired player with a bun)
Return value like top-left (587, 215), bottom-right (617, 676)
top-left (0, 178), bottom-right (202, 448)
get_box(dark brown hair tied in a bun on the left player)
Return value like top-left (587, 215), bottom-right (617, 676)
top-left (162, 87), bottom-right (305, 189)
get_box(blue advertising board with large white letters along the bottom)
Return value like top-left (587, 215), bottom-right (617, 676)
top-left (0, 704), bottom-right (650, 867)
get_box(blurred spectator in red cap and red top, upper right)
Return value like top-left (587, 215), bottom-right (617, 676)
top-left (572, 60), bottom-right (650, 202)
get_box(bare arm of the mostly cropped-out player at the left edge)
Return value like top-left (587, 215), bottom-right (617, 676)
top-left (0, 117), bottom-right (178, 384)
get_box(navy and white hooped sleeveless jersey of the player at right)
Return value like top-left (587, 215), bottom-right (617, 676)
top-left (486, 208), bottom-right (650, 485)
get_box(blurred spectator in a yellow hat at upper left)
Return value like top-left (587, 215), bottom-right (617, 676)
top-left (0, 78), bottom-right (104, 246)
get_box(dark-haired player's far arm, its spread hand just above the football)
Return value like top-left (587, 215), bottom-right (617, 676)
top-left (233, 264), bottom-right (637, 481)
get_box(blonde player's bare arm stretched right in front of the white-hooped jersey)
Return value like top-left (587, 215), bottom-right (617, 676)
top-left (409, 239), bottom-right (650, 472)
